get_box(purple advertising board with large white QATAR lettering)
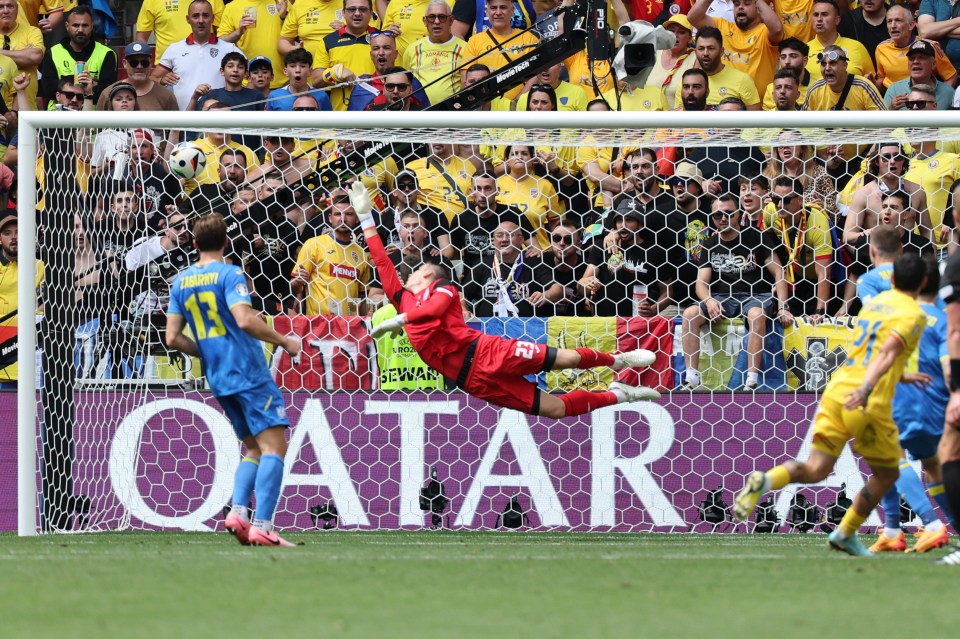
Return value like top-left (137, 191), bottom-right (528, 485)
top-left (0, 391), bottom-right (884, 532)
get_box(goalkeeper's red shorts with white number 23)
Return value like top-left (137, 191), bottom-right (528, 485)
top-left (462, 335), bottom-right (557, 414)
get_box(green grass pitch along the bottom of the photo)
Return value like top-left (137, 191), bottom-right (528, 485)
top-left (0, 531), bottom-right (960, 639)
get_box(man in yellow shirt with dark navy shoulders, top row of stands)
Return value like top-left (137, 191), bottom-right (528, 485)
top-left (311, 0), bottom-right (376, 111)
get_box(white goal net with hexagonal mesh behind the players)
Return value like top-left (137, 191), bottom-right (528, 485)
top-left (16, 112), bottom-right (960, 534)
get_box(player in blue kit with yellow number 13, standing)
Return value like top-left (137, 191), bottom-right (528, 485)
top-left (167, 213), bottom-right (300, 546)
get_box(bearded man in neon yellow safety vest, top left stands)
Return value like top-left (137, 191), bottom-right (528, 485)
top-left (38, 5), bottom-right (117, 109)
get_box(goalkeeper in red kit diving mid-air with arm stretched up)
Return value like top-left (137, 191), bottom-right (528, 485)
top-left (350, 181), bottom-right (660, 419)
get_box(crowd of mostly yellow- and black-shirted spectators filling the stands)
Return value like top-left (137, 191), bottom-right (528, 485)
top-left (0, 0), bottom-right (960, 390)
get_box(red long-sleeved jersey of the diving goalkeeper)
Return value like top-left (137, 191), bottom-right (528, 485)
top-left (367, 230), bottom-right (483, 381)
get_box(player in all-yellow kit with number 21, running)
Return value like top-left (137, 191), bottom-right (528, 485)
top-left (733, 253), bottom-right (929, 557)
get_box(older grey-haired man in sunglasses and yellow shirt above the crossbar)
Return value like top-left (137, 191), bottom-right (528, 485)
top-left (402, 0), bottom-right (467, 104)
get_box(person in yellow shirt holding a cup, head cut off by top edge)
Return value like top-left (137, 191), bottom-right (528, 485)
top-left (218, 0), bottom-right (288, 89)
